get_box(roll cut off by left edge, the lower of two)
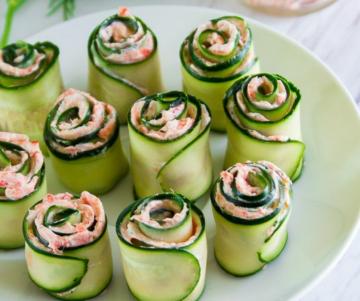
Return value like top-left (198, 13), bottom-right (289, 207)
top-left (0, 132), bottom-right (46, 249)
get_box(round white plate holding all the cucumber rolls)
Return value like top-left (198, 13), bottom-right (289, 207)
top-left (0, 6), bottom-right (360, 301)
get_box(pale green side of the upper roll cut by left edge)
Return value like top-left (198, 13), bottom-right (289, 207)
top-left (0, 58), bottom-right (63, 154)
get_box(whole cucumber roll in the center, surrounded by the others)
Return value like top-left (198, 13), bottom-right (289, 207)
top-left (128, 91), bottom-right (212, 201)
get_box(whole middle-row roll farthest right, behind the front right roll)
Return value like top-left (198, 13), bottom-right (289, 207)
top-left (224, 73), bottom-right (305, 181)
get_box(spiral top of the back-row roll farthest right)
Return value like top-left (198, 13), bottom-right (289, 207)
top-left (181, 16), bottom-right (257, 80)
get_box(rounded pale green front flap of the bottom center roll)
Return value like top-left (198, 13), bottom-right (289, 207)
top-left (120, 242), bottom-right (200, 301)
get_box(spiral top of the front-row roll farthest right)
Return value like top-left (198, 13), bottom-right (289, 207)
top-left (212, 161), bottom-right (292, 224)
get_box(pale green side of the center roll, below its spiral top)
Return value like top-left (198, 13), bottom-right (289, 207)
top-left (128, 116), bottom-right (212, 201)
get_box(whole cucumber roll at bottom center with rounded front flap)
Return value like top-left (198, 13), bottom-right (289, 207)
top-left (116, 193), bottom-right (207, 301)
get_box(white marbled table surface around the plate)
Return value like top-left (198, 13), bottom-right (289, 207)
top-left (0, 0), bottom-right (360, 301)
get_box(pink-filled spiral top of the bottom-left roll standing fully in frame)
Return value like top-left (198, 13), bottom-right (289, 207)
top-left (26, 191), bottom-right (106, 254)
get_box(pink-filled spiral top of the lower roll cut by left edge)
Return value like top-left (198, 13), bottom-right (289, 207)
top-left (0, 132), bottom-right (45, 201)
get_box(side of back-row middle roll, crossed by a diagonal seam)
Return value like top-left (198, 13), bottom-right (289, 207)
top-left (88, 50), bottom-right (163, 124)
